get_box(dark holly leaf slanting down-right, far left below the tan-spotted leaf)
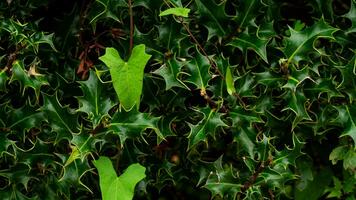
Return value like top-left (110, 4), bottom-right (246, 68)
top-left (40, 94), bottom-right (79, 143)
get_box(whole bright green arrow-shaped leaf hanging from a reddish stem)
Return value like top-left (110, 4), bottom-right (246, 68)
top-left (99, 44), bottom-right (151, 111)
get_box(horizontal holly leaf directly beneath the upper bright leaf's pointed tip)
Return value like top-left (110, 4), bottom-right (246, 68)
top-left (109, 111), bottom-right (164, 145)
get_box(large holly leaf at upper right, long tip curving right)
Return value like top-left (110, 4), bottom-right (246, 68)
top-left (281, 19), bottom-right (338, 64)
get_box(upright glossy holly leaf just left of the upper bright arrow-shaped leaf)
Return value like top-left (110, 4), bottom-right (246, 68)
top-left (77, 71), bottom-right (114, 127)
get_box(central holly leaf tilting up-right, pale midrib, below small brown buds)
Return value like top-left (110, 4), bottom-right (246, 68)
top-left (188, 107), bottom-right (226, 149)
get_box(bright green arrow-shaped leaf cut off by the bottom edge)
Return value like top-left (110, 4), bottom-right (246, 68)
top-left (93, 156), bottom-right (146, 200)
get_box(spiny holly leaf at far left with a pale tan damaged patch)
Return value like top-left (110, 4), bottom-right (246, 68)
top-left (10, 61), bottom-right (49, 99)
